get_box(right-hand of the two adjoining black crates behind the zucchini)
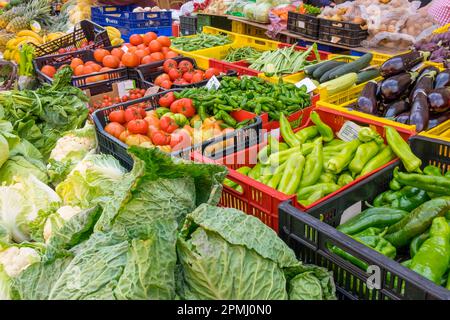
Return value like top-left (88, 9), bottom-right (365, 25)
top-left (319, 19), bottom-right (369, 47)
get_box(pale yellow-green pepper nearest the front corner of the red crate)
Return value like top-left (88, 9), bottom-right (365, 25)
top-left (277, 152), bottom-right (305, 195)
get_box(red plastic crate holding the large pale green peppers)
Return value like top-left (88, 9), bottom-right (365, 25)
top-left (194, 107), bottom-right (415, 232)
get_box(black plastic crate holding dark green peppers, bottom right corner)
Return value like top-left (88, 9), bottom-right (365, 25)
top-left (279, 136), bottom-right (450, 300)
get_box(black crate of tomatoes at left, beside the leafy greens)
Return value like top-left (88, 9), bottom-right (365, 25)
top-left (33, 47), bottom-right (128, 90)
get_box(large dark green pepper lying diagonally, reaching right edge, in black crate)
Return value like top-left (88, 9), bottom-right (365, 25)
top-left (385, 197), bottom-right (450, 248)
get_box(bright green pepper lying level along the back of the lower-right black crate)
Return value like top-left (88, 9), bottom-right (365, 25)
top-left (394, 168), bottom-right (450, 195)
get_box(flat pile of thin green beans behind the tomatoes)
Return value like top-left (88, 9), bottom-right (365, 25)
top-left (172, 33), bottom-right (232, 52)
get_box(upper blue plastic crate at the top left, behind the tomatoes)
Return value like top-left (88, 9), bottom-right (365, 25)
top-left (91, 6), bottom-right (172, 28)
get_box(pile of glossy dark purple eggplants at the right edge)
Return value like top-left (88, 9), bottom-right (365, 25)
top-left (355, 51), bottom-right (450, 132)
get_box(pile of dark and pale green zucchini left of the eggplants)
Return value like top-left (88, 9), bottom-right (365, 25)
top-left (305, 53), bottom-right (380, 95)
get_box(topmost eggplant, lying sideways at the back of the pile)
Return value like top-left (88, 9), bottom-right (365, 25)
top-left (380, 51), bottom-right (429, 78)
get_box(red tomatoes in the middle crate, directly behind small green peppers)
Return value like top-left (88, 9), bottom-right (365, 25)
top-left (154, 59), bottom-right (220, 89)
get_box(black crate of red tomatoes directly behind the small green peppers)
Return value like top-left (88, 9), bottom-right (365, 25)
top-left (136, 56), bottom-right (237, 89)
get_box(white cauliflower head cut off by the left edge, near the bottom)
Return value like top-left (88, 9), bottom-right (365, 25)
top-left (0, 246), bottom-right (41, 278)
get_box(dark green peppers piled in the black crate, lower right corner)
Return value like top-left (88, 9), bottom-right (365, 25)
top-left (330, 162), bottom-right (450, 290)
